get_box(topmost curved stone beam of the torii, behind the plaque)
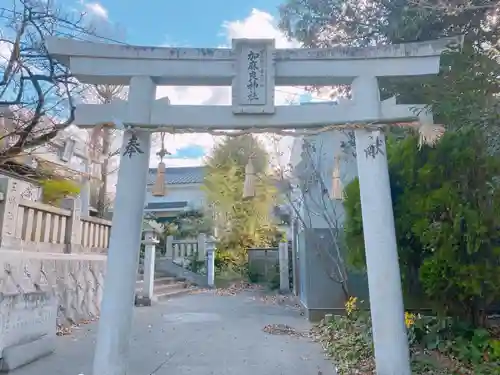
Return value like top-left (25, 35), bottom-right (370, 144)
top-left (47, 38), bottom-right (461, 86)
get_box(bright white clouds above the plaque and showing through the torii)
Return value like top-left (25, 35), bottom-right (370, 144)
top-left (150, 9), bottom-right (303, 166)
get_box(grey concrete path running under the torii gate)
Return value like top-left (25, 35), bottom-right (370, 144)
top-left (12, 292), bottom-right (335, 375)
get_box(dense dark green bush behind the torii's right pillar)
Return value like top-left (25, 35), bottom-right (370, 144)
top-left (345, 131), bottom-right (500, 325)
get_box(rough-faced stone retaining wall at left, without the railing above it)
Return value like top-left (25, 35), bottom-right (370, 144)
top-left (0, 250), bottom-right (106, 326)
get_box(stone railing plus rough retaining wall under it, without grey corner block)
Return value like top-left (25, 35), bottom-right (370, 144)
top-left (0, 176), bottom-right (111, 325)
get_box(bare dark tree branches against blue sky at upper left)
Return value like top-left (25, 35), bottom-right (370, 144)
top-left (0, 0), bottom-right (118, 164)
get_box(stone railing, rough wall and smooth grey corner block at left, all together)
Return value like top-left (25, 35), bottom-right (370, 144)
top-left (0, 176), bottom-right (111, 372)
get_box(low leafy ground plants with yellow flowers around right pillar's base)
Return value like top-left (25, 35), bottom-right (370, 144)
top-left (315, 297), bottom-right (500, 375)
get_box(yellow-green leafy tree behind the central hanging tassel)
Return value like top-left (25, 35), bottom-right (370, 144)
top-left (205, 135), bottom-right (276, 258)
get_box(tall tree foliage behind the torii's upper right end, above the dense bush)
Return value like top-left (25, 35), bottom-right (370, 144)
top-left (280, 0), bottom-right (500, 152)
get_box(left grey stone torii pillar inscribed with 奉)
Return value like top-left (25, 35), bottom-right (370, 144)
top-left (93, 77), bottom-right (156, 375)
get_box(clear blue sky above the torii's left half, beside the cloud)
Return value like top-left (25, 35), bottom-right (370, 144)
top-left (74, 0), bottom-right (281, 47)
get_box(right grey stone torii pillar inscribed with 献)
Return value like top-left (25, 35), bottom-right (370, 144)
top-left (351, 76), bottom-right (411, 375)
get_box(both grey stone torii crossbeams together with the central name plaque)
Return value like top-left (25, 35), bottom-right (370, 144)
top-left (47, 37), bottom-right (462, 131)
